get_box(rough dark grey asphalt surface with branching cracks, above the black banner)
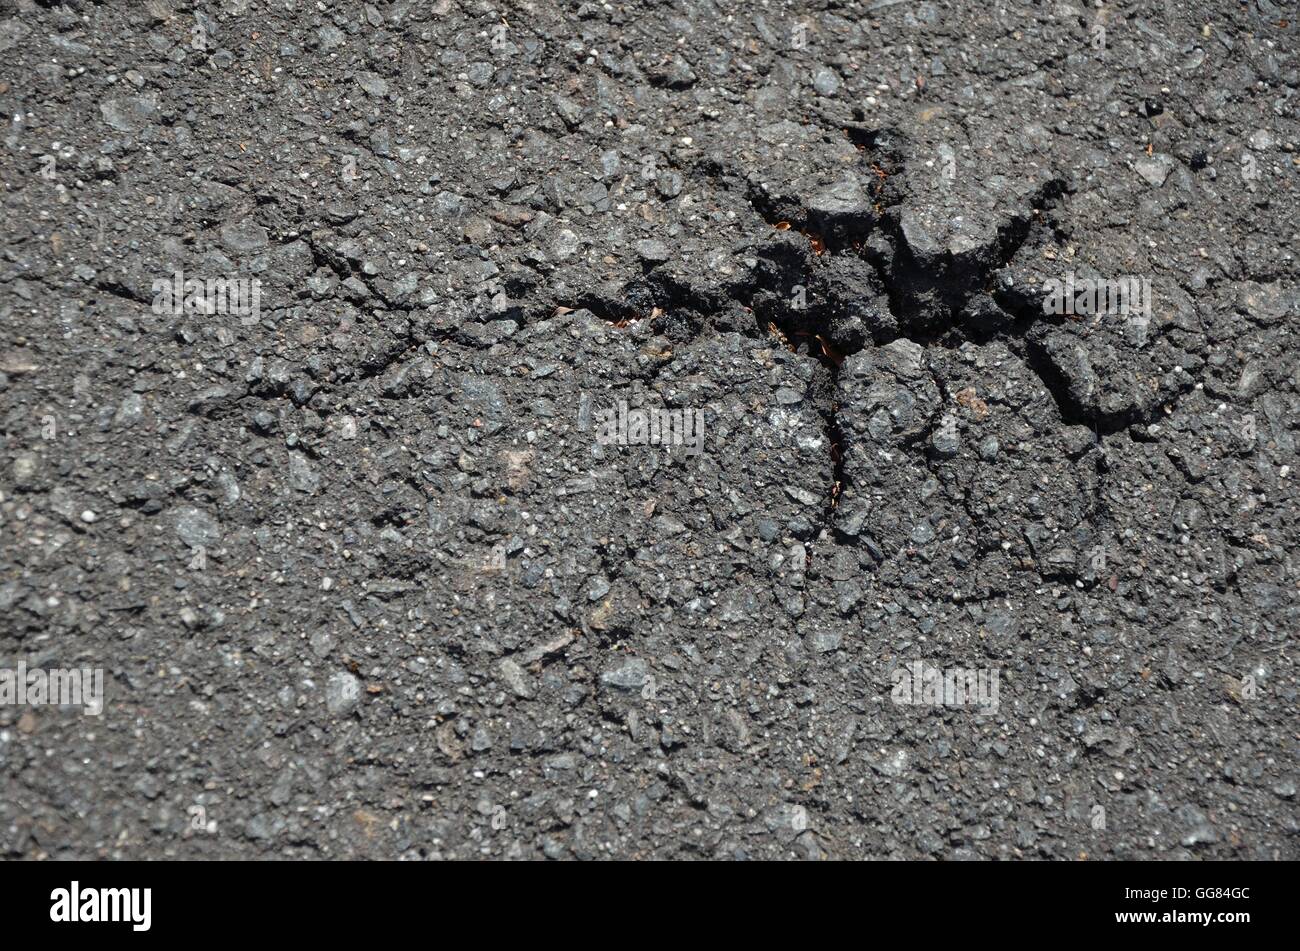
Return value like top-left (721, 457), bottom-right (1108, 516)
top-left (0, 0), bottom-right (1300, 860)
